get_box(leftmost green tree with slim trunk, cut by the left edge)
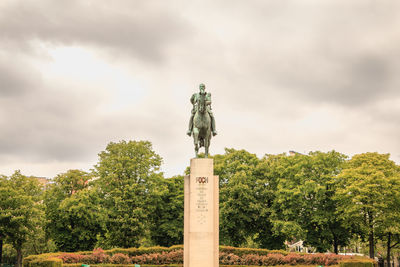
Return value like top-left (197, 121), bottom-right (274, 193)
top-left (0, 171), bottom-right (42, 266)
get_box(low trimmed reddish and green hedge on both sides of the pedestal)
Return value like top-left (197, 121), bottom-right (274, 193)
top-left (23, 245), bottom-right (377, 267)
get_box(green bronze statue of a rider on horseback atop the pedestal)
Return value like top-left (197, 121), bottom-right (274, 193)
top-left (187, 84), bottom-right (217, 158)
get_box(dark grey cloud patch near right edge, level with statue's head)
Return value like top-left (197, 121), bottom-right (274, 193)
top-left (280, 51), bottom-right (399, 106)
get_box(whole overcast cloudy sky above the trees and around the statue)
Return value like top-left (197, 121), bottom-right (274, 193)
top-left (0, 0), bottom-right (400, 178)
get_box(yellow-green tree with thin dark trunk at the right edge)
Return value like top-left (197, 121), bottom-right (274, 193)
top-left (337, 153), bottom-right (400, 258)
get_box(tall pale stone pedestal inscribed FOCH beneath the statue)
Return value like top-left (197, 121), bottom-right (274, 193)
top-left (183, 158), bottom-right (219, 267)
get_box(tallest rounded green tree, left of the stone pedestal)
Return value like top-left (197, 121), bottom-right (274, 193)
top-left (95, 141), bottom-right (163, 248)
